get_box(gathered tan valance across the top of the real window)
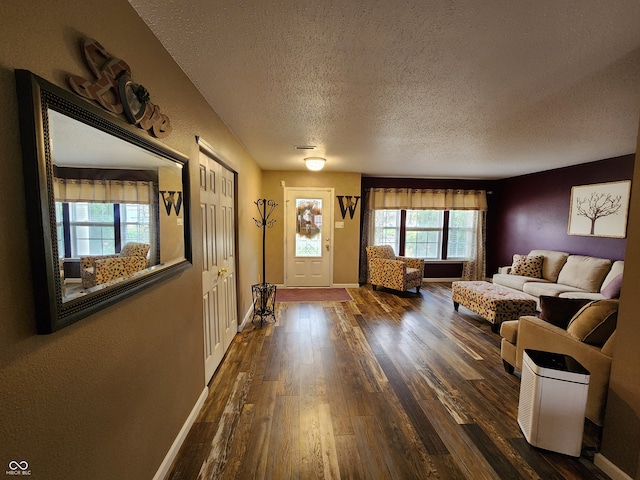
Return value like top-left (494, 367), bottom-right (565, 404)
top-left (368, 188), bottom-right (487, 211)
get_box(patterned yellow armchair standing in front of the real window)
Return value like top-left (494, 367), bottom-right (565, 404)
top-left (367, 245), bottom-right (424, 292)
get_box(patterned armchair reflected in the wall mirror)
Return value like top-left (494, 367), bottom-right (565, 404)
top-left (80, 242), bottom-right (150, 288)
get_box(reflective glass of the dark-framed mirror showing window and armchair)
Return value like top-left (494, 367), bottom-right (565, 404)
top-left (48, 109), bottom-right (185, 302)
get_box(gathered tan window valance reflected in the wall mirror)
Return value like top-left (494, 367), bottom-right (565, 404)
top-left (53, 178), bottom-right (156, 204)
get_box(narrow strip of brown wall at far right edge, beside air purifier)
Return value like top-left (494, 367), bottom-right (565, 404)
top-left (602, 116), bottom-right (640, 479)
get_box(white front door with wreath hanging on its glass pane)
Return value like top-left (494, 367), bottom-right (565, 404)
top-left (285, 188), bottom-right (333, 287)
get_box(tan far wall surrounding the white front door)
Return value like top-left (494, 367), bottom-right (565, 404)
top-left (262, 171), bottom-right (362, 284)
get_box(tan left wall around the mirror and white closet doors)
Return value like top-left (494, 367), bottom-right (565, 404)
top-left (0, 0), bottom-right (262, 480)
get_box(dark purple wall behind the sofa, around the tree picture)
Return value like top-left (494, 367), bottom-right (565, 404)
top-left (487, 155), bottom-right (635, 276)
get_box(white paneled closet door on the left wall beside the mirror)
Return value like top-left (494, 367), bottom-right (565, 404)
top-left (199, 152), bottom-right (238, 383)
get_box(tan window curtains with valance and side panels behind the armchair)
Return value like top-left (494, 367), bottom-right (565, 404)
top-left (359, 188), bottom-right (487, 282)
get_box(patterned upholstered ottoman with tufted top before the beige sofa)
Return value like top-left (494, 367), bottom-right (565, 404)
top-left (451, 282), bottom-right (536, 333)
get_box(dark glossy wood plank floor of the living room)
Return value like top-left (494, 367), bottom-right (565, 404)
top-left (162, 283), bottom-right (608, 480)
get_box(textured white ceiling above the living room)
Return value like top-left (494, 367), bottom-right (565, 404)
top-left (129, 0), bottom-right (640, 178)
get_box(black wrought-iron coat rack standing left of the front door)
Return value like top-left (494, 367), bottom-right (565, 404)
top-left (251, 198), bottom-right (278, 326)
